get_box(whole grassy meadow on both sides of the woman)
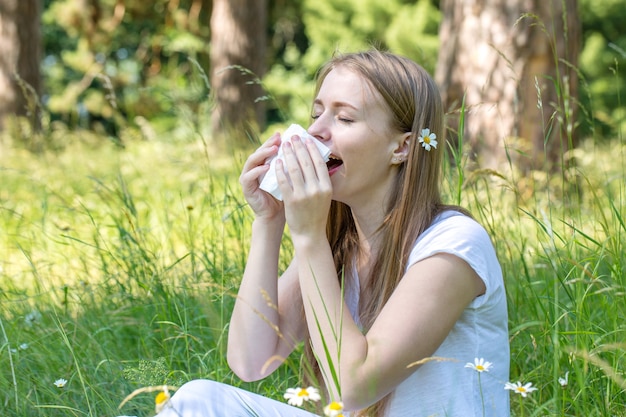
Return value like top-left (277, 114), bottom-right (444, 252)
top-left (0, 124), bottom-right (626, 417)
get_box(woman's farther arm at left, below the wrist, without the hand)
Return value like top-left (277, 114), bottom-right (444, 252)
top-left (227, 214), bottom-right (303, 381)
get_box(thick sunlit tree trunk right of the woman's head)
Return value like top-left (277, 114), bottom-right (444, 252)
top-left (435, 0), bottom-right (581, 172)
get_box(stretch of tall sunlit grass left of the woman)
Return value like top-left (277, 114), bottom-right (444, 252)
top-left (0, 143), bottom-right (295, 416)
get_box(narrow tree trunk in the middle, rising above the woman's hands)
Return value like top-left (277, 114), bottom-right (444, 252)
top-left (211, 0), bottom-right (267, 148)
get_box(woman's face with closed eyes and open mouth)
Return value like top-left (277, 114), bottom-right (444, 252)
top-left (308, 67), bottom-right (408, 208)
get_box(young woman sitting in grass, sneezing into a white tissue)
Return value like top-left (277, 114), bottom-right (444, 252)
top-left (155, 50), bottom-right (509, 417)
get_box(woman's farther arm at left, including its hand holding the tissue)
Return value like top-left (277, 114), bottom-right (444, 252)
top-left (227, 135), bottom-right (304, 381)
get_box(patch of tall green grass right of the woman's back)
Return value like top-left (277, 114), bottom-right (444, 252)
top-left (458, 141), bottom-right (626, 416)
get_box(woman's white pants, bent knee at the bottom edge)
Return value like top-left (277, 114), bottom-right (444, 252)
top-left (157, 379), bottom-right (316, 417)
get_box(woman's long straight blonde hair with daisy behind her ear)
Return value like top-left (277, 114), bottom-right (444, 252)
top-left (305, 49), bottom-right (466, 416)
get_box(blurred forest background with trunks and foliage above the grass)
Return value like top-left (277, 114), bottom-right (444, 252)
top-left (0, 0), bottom-right (626, 171)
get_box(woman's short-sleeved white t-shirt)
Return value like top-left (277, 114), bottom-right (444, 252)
top-left (345, 211), bottom-right (510, 417)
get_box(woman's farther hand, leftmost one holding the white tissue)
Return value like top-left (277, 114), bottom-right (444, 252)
top-left (239, 133), bottom-right (284, 220)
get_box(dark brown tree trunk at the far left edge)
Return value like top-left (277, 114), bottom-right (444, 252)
top-left (0, 0), bottom-right (41, 130)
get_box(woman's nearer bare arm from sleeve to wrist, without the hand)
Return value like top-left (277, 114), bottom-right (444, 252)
top-left (294, 245), bottom-right (484, 410)
